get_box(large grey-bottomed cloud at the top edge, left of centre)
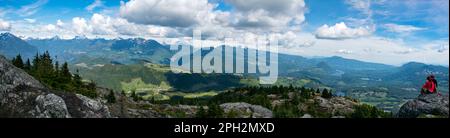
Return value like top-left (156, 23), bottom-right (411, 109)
top-left (120, 0), bottom-right (214, 27)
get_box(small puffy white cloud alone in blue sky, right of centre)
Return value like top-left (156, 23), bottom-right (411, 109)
top-left (316, 22), bottom-right (373, 39)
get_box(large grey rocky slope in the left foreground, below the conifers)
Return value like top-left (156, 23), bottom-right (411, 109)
top-left (0, 56), bottom-right (111, 118)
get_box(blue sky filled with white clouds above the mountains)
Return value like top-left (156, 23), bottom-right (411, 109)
top-left (0, 0), bottom-right (449, 66)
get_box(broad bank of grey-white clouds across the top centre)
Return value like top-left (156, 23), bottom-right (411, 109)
top-left (120, 0), bottom-right (306, 38)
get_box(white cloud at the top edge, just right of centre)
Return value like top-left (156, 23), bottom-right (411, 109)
top-left (225, 0), bottom-right (306, 31)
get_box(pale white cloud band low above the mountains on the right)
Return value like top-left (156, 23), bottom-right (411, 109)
top-left (280, 33), bottom-right (449, 66)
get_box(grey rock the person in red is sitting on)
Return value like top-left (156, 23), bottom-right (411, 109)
top-left (397, 94), bottom-right (449, 118)
